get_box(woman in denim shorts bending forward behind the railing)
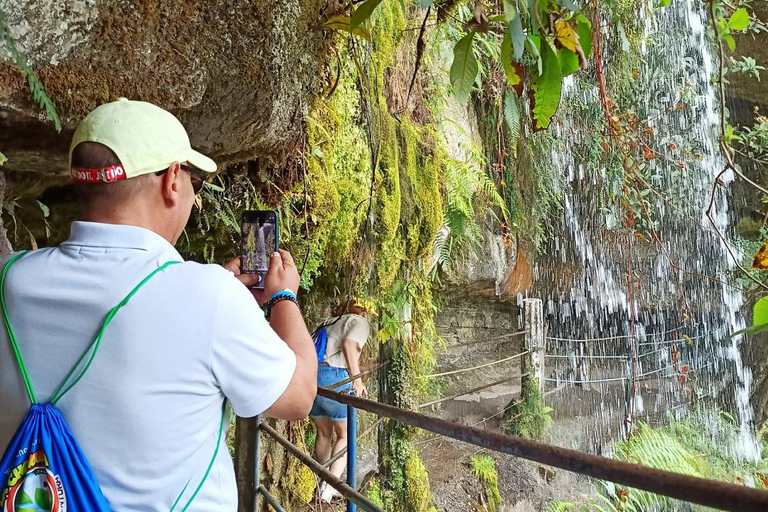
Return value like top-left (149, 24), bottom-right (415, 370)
top-left (309, 299), bottom-right (371, 503)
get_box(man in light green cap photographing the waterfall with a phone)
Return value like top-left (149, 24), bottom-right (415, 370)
top-left (0, 99), bottom-right (317, 512)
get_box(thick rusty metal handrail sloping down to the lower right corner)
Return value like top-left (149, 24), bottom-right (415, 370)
top-left (320, 387), bottom-right (768, 512)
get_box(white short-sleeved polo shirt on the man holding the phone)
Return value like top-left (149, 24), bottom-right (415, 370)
top-left (0, 222), bottom-right (296, 512)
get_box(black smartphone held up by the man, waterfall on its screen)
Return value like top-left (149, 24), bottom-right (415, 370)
top-left (240, 210), bottom-right (280, 290)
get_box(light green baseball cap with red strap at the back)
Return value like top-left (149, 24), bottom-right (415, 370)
top-left (69, 98), bottom-right (216, 182)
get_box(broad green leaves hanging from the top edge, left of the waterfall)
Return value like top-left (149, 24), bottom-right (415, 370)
top-left (325, 0), bottom-right (592, 130)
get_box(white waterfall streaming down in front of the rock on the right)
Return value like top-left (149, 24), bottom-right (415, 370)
top-left (535, 0), bottom-right (760, 460)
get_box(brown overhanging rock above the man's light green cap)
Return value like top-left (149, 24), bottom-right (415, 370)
top-left (0, 0), bottom-right (328, 174)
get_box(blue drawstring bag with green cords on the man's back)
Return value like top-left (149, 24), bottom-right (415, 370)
top-left (0, 253), bottom-right (224, 512)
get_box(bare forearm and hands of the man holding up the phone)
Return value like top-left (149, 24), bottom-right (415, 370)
top-left (225, 251), bottom-right (317, 420)
